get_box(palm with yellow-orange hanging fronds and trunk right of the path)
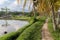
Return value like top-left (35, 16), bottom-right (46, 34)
top-left (38, 0), bottom-right (59, 30)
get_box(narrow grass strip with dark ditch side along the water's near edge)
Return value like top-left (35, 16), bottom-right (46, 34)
top-left (0, 20), bottom-right (34, 40)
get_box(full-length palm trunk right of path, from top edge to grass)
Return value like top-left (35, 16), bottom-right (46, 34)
top-left (50, 0), bottom-right (58, 31)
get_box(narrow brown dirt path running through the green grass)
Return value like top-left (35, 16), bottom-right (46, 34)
top-left (42, 19), bottom-right (53, 40)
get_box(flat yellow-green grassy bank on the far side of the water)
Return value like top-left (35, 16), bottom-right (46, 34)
top-left (0, 16), bottom-right (31, 21)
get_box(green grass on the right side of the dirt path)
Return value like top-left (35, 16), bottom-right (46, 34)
top-left (48, 20), bottom-right (60, 40)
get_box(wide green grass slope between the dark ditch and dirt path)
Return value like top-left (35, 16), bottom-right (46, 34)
top-left (16, 21), bottom-right (44, 40)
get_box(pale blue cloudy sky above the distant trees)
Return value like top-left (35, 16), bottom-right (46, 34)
top-left (0, 0), bottom-right (32, 12)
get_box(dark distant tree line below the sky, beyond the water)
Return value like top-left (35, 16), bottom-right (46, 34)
top-left (0, 11), bottom-right (39, 17)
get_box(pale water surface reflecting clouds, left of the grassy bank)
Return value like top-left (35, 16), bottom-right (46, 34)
top-left (0, 20), bottom-right (28, 36)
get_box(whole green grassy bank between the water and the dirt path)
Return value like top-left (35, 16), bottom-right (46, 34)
top-left (0, 18), bottom-right (45, 40)
